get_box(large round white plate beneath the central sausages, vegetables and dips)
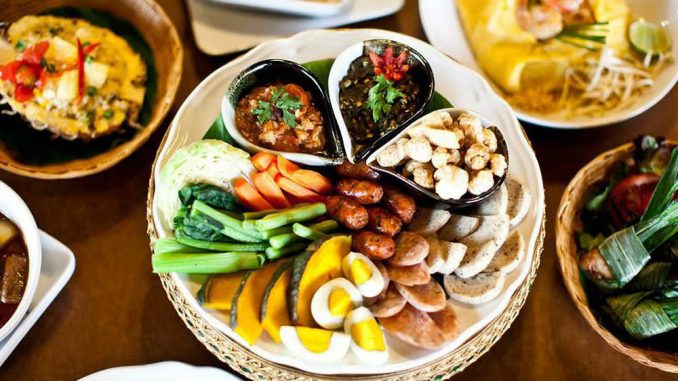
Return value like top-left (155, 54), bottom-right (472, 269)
top-left (153, 29), bottom-right (544, 374)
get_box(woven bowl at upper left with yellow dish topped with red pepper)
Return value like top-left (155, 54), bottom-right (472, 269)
top-left (0, 0), bottom-right (182, 178)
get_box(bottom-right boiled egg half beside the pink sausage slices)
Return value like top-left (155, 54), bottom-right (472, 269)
top-left (344, 307), bottom-right (388, 365)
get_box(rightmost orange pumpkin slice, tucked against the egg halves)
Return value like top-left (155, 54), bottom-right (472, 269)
top-left (287, 235), bottom-right (351, 327)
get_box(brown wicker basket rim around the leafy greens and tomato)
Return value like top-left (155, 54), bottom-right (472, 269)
top-left (556, 142), bottom-right (678, 373)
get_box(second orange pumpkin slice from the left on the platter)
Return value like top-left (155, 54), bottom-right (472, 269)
top-left (231, 261), bottom-right (285, 345)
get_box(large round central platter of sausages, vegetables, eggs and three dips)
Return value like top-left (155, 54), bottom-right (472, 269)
top-left (148, 30), bottom-right (544, 379)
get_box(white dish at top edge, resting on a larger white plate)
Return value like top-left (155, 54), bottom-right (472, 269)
top-left (205, 0), bottom-right (352, 17)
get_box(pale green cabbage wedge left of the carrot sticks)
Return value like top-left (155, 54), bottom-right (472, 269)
top-left (155, 139), bottom-right (255, 228)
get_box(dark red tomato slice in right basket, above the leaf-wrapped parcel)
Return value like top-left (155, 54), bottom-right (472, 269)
top-left (610, 173), bottom-right (659, 228)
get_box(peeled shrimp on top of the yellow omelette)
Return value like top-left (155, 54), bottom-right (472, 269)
top-left (516, 0), bottom-right (563, 40)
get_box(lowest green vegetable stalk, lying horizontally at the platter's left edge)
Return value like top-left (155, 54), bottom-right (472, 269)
top-left (152, 252), bottom-right (265, 274)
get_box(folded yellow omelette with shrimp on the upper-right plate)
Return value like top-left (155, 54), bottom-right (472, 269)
top-left (456, 0), bottom-right (630, 111)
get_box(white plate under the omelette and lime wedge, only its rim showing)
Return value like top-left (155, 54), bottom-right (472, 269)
top-left (419, 0), bottom-right (678, 129)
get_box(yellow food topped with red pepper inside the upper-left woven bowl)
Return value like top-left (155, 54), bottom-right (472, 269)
top-left (0, 16), bottom-right (146, 140)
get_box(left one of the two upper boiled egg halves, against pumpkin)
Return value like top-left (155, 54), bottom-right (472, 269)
top-left (311, 278), bottom-right (363, 329)
